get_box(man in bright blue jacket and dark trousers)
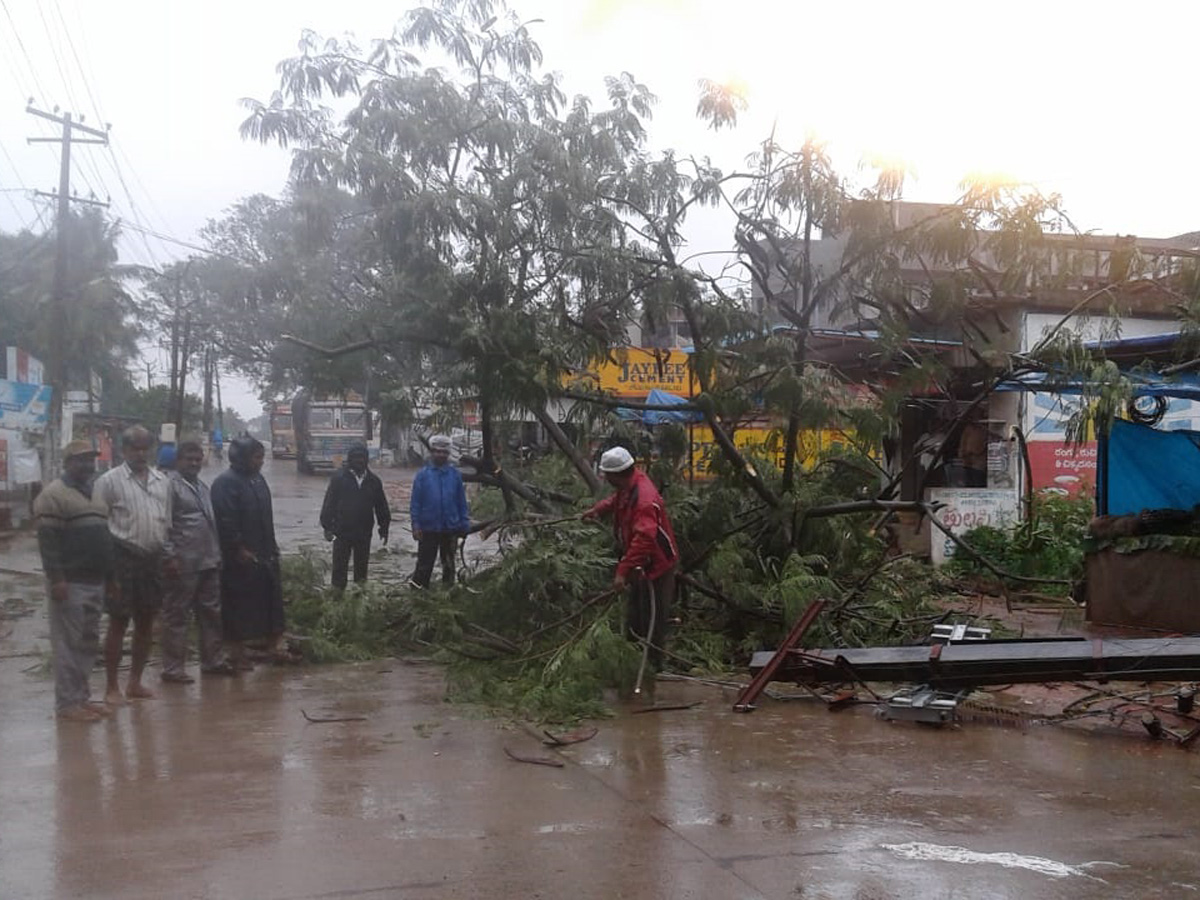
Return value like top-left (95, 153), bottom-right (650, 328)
top-left (409, 434), bottom-right (470, 588)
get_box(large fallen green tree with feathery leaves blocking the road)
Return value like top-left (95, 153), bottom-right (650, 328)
top-left (215, 0), bottom-right (1195, 718)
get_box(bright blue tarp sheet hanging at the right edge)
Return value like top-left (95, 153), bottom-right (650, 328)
top-left (1097, 419), bottom-right (1200, 516)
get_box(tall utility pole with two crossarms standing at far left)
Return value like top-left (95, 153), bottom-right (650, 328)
top-left (25, 103), bottom-right (108, 481)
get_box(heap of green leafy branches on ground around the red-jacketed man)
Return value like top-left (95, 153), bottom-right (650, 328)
top-left (284, 453), bottom-right (988, 721)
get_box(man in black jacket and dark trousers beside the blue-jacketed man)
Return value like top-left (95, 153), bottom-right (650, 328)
top-left (320, 443), bottom-right (391, 590)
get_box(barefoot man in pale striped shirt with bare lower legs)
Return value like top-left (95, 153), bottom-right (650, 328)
top-left (95, 426), bottom-right (170, 706)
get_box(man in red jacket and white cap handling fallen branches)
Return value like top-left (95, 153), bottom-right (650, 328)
top-left (583, 446), bottom-right (679, 670)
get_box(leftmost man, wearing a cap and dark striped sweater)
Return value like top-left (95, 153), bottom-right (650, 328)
top-left (34, 440), bottom-right (113, 722)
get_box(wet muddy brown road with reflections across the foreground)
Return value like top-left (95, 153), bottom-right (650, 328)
top-left (0, 460), bottom-right (1200, 900)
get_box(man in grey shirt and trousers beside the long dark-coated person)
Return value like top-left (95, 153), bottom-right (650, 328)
top-left (162, 440), bottom-right (235, 684)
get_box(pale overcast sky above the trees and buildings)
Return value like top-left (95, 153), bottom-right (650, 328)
top-left (0, 0), bottom-right (1200, 415)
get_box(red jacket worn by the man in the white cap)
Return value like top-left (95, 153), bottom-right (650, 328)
top-left (590, 469), bottom-right (679, 580)
